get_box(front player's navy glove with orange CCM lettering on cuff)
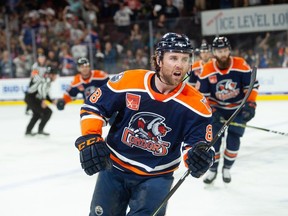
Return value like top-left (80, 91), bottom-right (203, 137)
top-left (75, 134), bottom-right (111, 175)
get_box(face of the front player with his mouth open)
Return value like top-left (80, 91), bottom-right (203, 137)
top-left (160, 52), bottom-right (191, 87)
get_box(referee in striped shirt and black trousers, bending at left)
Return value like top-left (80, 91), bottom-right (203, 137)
top-left (25, 67), bottom-right (58, 136)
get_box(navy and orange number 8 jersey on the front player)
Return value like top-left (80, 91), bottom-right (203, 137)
top-left (80, 70), bottom-right (212, 177)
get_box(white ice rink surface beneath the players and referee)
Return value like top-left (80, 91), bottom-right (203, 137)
top-left (0, 101), bottom-right (288, 216)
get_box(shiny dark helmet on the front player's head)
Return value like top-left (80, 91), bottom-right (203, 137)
top-left (156, 32), bottom-right (193, 54)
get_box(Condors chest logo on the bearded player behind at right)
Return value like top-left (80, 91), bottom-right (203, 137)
top-left (215, 79), bottom-right (240, 100)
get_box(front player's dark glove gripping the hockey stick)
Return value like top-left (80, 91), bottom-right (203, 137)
top-left (185, 142), bottom-right (215, 178)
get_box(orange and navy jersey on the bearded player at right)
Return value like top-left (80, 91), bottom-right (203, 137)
top-left (196, 57), bottom-right (259, 110)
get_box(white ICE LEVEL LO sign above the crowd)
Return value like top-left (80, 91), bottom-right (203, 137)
top-left (201, 4), bottom-right (288, 35)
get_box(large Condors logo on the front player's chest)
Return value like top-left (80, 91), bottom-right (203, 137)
top-left (121, 112), bottom-right (171, 156)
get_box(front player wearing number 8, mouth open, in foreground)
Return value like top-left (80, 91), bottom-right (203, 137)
top-left (75, 33), bottom-right (214, 216)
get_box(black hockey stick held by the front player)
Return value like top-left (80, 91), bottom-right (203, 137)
top-left (151, 67), bottom-right (257, 216)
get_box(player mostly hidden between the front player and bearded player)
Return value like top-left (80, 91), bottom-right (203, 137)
top-left (188, 42), bottom-right (212, 87)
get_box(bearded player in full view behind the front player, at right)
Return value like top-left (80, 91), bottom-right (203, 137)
top-left (196, 37), bottom-right (259, 184)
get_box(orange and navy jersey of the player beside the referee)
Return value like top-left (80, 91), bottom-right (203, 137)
top-left (63, 70), bottom-right (109, 103)
